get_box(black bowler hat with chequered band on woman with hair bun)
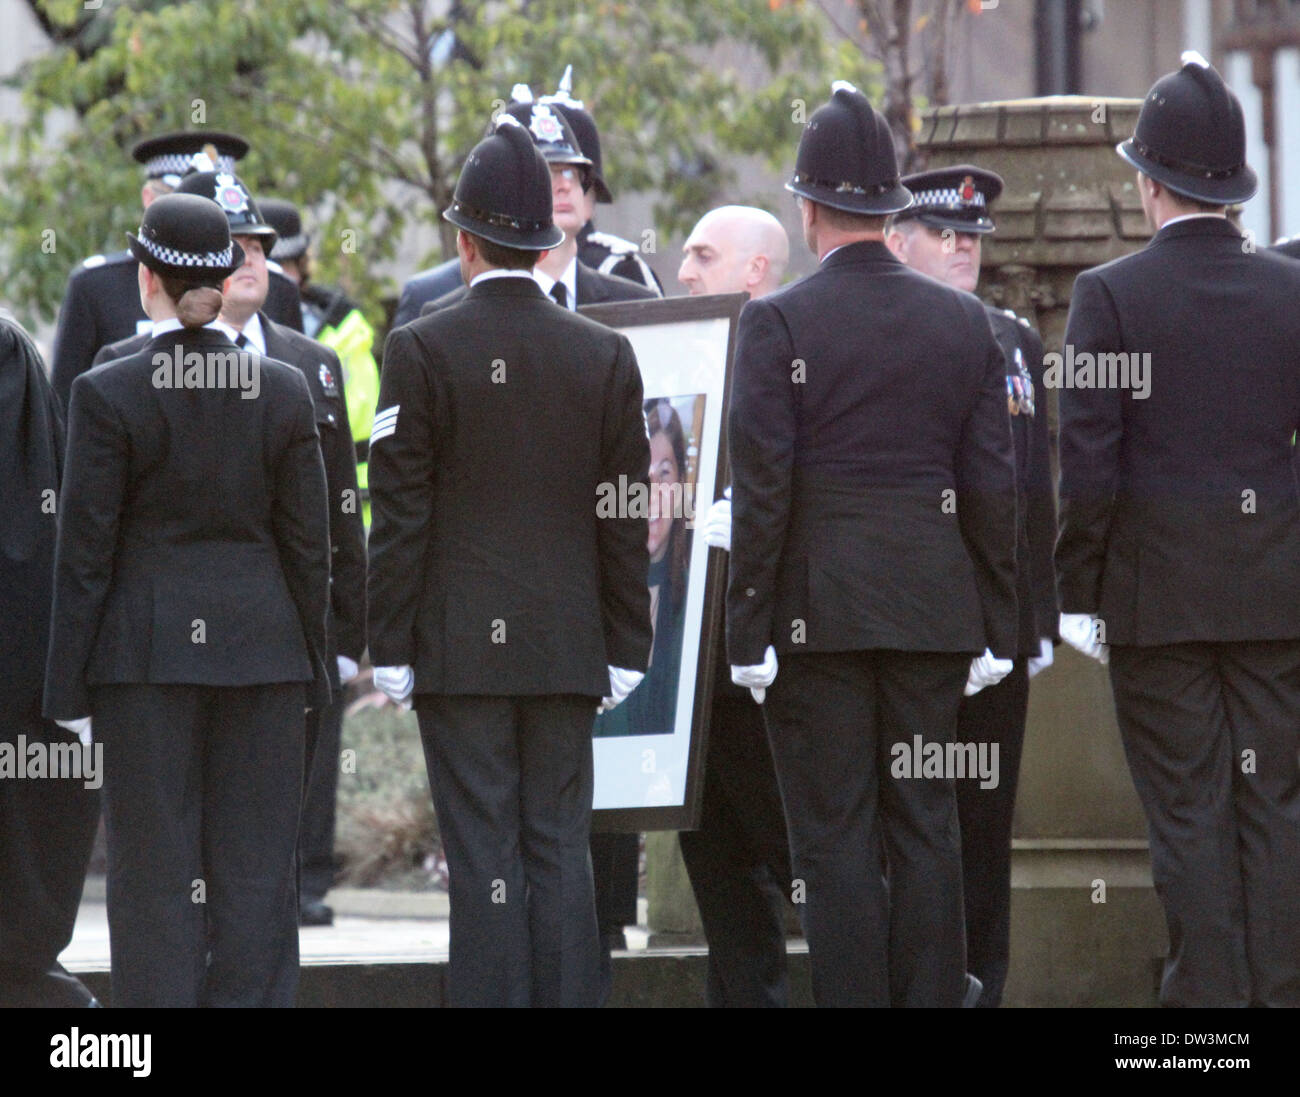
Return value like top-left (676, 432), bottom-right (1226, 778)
top-left (126, 194), bottom-right (244, 285)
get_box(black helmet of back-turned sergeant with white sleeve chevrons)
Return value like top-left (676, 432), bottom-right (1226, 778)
top-left (442, 112), bottom-right (564, 251)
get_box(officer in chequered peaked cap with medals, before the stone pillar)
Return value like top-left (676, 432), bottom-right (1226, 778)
top-left (885, 164), bottom-right (1060, 1007)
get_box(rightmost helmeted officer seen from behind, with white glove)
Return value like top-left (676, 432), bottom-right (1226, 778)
top-left (1047, 52), bottom-right (1300, 1006)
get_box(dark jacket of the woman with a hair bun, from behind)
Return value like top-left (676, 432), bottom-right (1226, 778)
top-left (44, 329), bottom-right (329, 719)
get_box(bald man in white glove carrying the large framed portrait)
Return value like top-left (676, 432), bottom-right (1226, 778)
top-left (677, 205), bottom-right (792, 1006)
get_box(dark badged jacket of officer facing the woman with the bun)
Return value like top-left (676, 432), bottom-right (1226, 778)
top-left (95, 313), bottom-right (365, 670)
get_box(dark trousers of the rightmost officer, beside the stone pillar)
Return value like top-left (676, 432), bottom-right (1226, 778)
top-left (1110, 639), bottom-right (1300, 1006)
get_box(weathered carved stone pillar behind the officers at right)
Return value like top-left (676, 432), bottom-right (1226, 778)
top-left (919, 96), bottom-right (1166, 1006)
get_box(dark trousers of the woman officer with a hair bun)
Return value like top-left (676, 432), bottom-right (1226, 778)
top-left (91, 682), bottom-right (304, 1007)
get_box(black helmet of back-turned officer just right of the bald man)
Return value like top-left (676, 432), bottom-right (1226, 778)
top-left (785, 81), bottom-right (911, 216)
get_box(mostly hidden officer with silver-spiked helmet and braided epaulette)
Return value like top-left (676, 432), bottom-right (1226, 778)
top-left (393, 66), bottom-right (663, 328)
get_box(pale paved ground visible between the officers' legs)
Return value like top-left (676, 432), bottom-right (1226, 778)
top-left (60, 876), bottom-right (647, 972)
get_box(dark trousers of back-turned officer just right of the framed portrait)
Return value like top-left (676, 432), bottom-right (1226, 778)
top-left (764, 651), bottom-right (970, 1007)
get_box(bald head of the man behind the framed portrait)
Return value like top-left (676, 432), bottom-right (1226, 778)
top-left (677, 205), bottom-right (790, 298)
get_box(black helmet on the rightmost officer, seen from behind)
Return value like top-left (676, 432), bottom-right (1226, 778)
top-left (1115, 49), bottom-right (1258, 205)
